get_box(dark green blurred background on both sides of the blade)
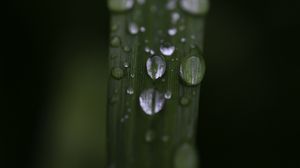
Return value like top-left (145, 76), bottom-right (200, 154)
top-left (5, 0), bottom-right (300, 168)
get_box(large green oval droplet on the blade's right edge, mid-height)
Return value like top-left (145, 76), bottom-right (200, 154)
top-left (180, 56), bottom-right (205, 85)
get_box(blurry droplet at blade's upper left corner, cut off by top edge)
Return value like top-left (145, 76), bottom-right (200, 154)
top-left (108, 0), bottom-right (134, 12)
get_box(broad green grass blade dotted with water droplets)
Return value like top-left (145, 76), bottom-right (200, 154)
top-left (108, 0), bottom-right (209, 168)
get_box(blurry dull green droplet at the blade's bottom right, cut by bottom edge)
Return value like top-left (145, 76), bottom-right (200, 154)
top-left (174, 143), bottom-right (198, 168)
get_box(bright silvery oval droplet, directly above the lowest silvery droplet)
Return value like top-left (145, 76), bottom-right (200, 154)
top-left (146, 56), bottom-right (167, 80)
